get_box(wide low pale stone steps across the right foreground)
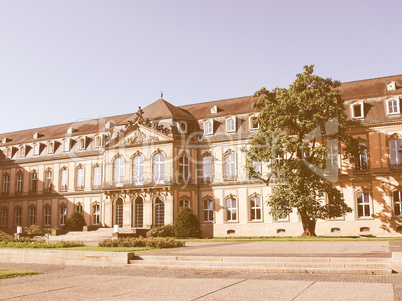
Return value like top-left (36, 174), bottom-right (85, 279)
top-left (130, 255), bottom-right (392, 275)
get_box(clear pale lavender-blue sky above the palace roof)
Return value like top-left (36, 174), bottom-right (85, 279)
top-left (0, 0), bottom-right (402, 133)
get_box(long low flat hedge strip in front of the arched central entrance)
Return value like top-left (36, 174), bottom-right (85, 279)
top-left (99, 237), bottom-right (184, 249)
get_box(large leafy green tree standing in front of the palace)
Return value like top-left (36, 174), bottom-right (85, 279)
top-left (247, 65), bottom-right (357, 236)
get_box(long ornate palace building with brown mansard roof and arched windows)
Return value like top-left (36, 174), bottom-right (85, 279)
top-left (0, 75), bottom-right (402, 237)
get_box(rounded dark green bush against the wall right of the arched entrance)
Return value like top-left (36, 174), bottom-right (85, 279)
top-left (174, 207), bottom-right (201, 238)
